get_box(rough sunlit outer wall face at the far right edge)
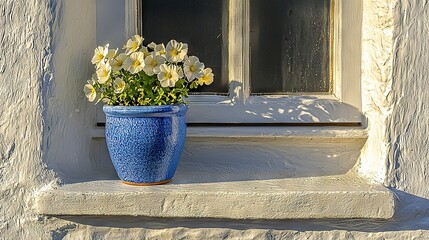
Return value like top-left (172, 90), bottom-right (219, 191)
top-left (386, 0), bottom-right (429, 198)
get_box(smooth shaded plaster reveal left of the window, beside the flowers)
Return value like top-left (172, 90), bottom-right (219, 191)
top-left (44, 0), bottom-right (103, 180)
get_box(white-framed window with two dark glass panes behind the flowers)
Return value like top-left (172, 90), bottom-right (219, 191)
top-left (97, 0), bottom-right (363, 125)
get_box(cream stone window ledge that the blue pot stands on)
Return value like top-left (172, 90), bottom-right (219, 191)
top-left (37, 175), bottom-right (394, 219)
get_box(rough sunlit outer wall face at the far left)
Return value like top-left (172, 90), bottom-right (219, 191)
top-left (0, 0), bottom-right (55, 239)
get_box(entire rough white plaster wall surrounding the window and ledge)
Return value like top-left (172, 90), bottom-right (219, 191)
top-left (0, 0), bottom-right (429, 239)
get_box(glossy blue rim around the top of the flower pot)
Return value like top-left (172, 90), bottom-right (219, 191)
top-left (103, 104), bottom-right (188, 117)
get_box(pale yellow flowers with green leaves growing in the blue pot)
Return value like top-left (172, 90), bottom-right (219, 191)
top-left (84, 35), bottom-right (214, 106)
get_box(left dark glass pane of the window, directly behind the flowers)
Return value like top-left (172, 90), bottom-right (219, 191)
top-left (142, 0), bottom-right (228, 93)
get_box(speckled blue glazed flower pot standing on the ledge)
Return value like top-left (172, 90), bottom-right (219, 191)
top-left (103, 104), bottom-right (188, 185)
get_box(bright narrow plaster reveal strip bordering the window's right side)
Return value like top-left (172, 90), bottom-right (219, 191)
top-left (359, 0), bottom-right (396, 182)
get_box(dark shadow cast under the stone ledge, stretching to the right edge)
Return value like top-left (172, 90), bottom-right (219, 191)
top-left (56, 190), bottom-right (429, 232)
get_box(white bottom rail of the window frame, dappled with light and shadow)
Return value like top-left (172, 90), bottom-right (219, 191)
top-left (188, 81), bottom-right (364, 125)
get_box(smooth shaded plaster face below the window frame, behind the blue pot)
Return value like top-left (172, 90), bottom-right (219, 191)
top-left (72, 138), bottom-right (366, 184)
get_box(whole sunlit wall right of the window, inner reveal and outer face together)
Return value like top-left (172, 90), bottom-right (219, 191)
top-left (360, 0), bottom-right (429, 198)
